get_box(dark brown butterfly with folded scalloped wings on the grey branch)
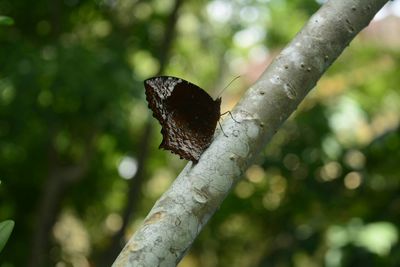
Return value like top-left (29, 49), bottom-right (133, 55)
top-left (144, 76), bottom-right (221, 163)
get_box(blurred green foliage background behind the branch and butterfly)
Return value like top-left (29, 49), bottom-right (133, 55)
top-left (0, 0), bottom-right (400, 267)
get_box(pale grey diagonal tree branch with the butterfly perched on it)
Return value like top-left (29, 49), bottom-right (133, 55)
top-left (113, 0), bottom-right (387, 267)
